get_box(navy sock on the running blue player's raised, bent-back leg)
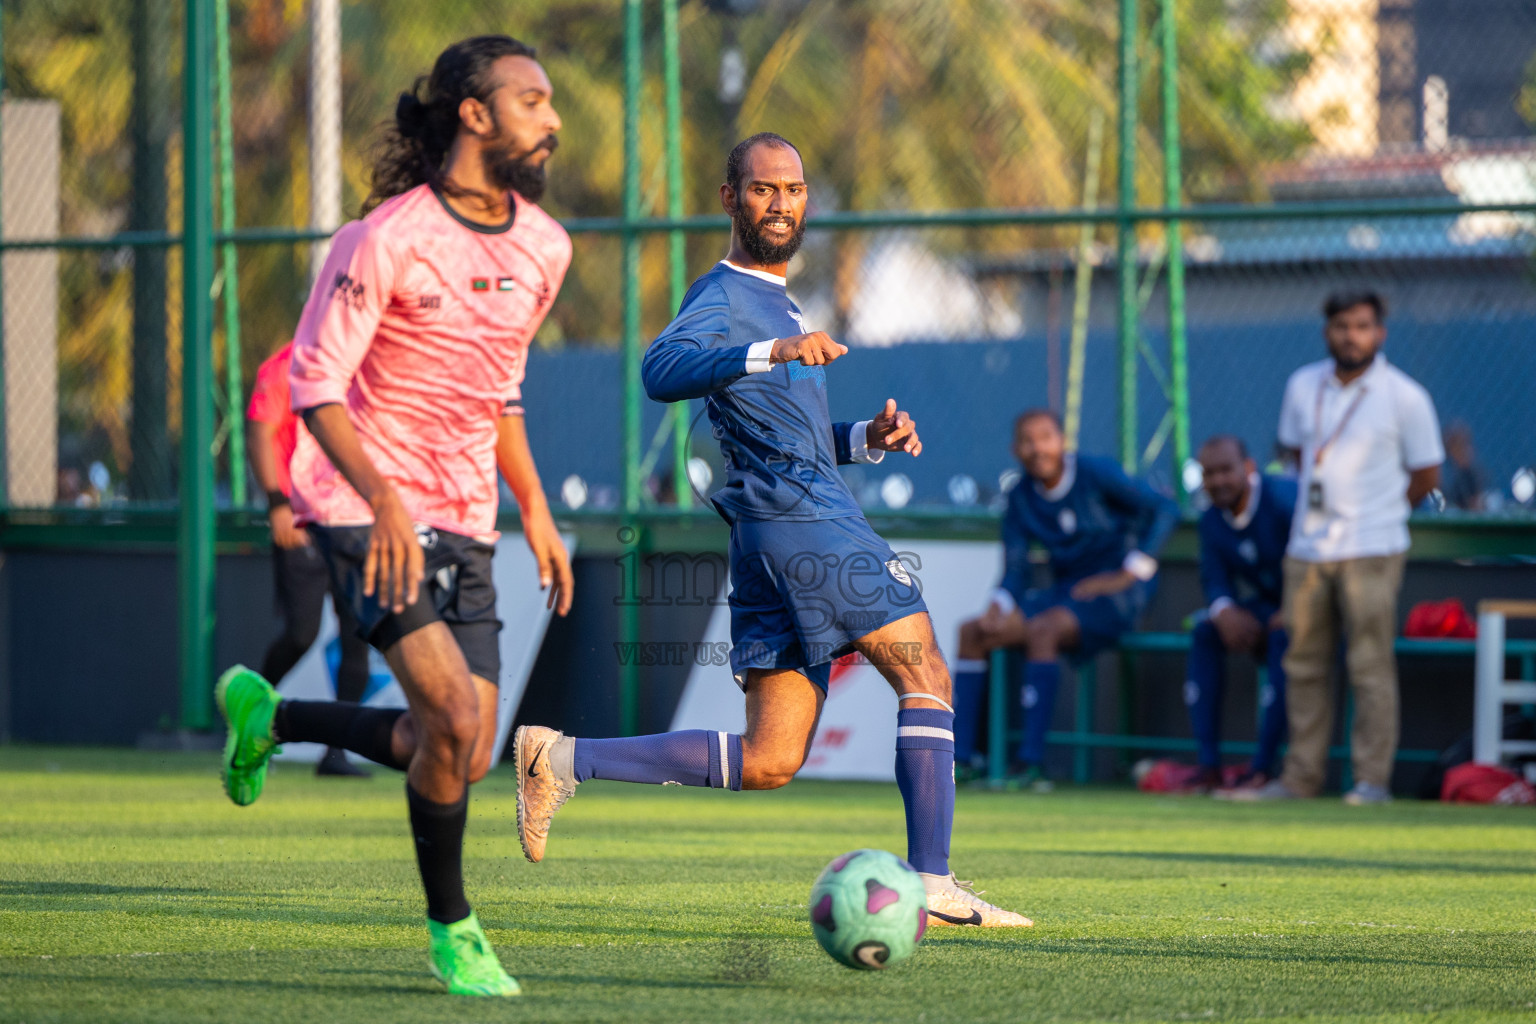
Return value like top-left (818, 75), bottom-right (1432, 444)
top-left (573, 729), bottom-right (742, 789)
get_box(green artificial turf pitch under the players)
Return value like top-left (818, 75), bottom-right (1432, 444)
top-left (0, 748), bottom-right (1536, 1024)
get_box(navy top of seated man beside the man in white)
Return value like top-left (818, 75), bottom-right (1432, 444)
top-left (1200, 476), bottom-right (1296, 608)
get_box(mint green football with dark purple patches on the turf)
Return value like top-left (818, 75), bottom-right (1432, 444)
top-left (811, 851), bottom-right (928, 970)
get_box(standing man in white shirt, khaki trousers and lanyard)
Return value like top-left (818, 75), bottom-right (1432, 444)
top-left (1233, 292), bottom-right (1445, 804)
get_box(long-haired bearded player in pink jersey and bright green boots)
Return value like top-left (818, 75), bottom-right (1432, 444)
top-left (215, 35), bottom-right (571, 996)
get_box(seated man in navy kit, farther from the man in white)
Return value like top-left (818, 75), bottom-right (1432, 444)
top-left (955, 408), bottom-right (1178, 789)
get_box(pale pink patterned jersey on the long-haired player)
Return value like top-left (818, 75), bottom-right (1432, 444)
top-left (290, 186), bottom-right (571, 537)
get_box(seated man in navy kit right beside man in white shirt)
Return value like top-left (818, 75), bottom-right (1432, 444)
top-left (1184, 434), bottom-right (1296, 792)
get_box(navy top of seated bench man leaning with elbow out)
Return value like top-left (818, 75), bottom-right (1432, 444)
top-left (1001, 454), bottom-right (1178, 603)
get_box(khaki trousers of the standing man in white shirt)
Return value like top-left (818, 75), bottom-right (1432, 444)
top-left (1281, 554), bottom-right (1407, 797)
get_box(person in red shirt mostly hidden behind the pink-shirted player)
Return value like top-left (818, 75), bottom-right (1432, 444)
top-left (246, 341), bottom-right (370, 778)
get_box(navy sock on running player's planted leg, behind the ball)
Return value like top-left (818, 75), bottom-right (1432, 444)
top-left (895, 708), bottom-right (955, 875)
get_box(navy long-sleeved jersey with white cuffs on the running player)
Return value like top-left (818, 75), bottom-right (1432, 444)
top-left (641, 261), bottom-right (863, 522)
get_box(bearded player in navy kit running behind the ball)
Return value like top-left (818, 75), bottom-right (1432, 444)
top-left (513, 134), bottom-right (1031, 927)
